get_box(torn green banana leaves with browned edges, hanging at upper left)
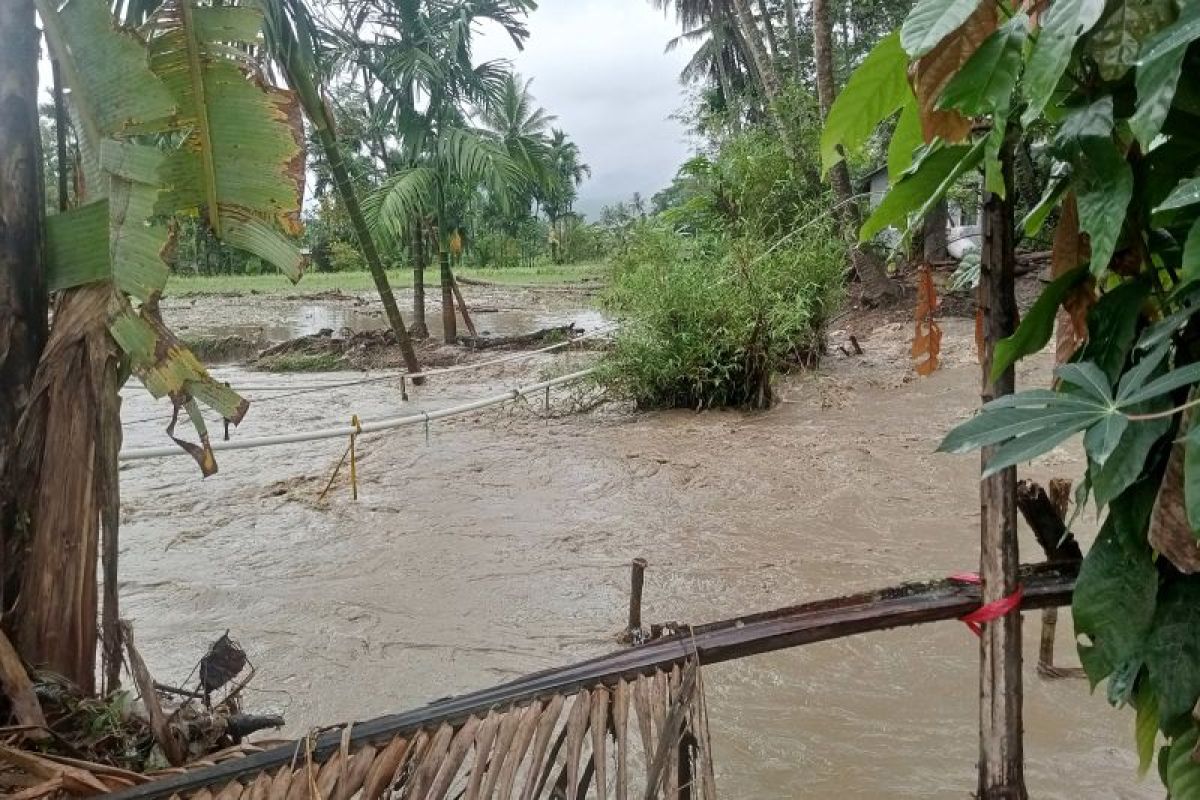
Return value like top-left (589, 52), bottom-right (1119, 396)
top-left (37, 0), bottom-right (305, 474)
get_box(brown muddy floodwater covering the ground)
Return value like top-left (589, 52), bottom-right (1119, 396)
top-left (120, 291), bottom-right (1163, 800)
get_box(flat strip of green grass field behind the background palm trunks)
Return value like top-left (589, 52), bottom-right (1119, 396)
top-left (167, 261), bottom-right (608, 297)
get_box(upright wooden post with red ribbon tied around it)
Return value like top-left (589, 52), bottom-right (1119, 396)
top-left (977, 134), bottom-right (1028, 800)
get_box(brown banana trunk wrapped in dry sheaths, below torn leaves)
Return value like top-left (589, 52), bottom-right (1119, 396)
top-left (12, 282), bottom-right (121, 694)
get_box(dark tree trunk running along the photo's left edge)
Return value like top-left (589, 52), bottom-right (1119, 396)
top-left (0, 0), bottom-right (47, 632)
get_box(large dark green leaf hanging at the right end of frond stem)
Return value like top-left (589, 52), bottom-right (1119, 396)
top-left (1072, 509), bottom-right (1158, 687)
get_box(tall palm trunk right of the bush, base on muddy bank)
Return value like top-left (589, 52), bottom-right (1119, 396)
top-left (812, 0), bottom-right (895, 302)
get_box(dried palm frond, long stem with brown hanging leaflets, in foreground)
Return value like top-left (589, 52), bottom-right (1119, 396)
top-left (100, 564), bottom-right (1078, 800)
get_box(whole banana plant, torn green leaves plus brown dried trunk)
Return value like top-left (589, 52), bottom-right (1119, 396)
top-left (12, 0), bottom-right (305, 692)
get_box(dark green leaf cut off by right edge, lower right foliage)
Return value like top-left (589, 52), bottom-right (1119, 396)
top-left (1146, 577), bottom-right (1200, 724)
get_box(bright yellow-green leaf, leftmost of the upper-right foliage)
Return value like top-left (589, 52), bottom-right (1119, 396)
top-left (821, 31), bottom-right (919, 179)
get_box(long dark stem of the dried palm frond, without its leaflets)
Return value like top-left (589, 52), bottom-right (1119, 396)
top-left (105, 564), bottom-right (1079, 800)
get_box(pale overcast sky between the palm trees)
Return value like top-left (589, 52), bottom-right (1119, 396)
top-left (475, 0), bottom-right (690, 219)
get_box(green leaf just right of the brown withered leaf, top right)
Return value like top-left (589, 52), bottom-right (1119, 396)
top-left (937, 13), bottom-right (1030, 118)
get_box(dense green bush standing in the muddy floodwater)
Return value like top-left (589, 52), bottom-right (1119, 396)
top-left (600, 218), bottom-right (846, 408)
